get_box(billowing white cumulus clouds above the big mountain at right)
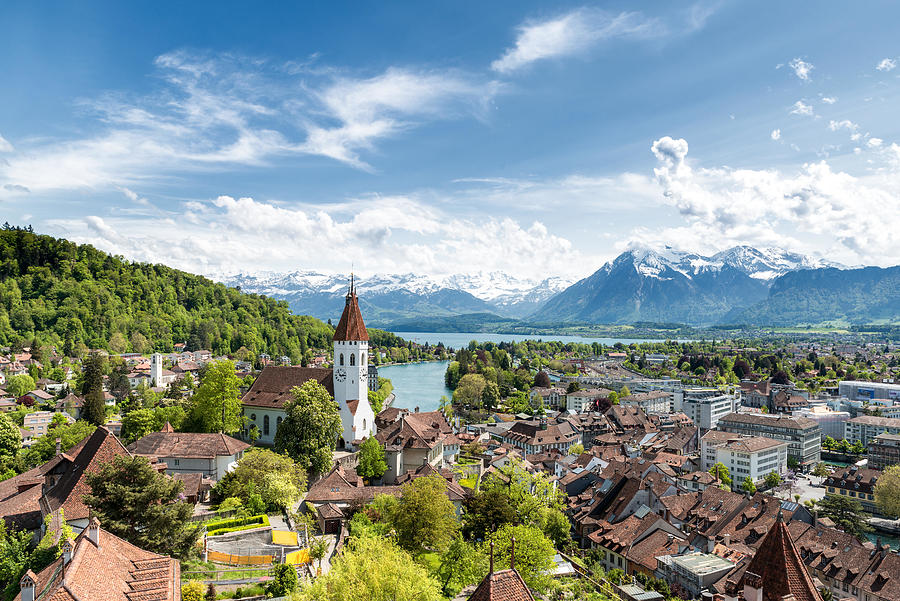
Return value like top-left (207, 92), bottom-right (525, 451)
top-left (651, 137), bottom-right (900, 264)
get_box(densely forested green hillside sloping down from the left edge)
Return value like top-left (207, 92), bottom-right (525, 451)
top-left (0, 225), bottom-right (332, 361)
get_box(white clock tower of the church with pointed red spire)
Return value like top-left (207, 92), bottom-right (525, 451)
top-left (332, 276), bottom-right (375, 447)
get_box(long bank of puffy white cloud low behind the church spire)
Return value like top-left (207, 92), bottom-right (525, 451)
top-left (49, 196), bottom-right (585, 277)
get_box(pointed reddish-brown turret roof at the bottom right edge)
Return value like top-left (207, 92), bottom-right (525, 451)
top-left (726, 511), bottom-right (822, 601)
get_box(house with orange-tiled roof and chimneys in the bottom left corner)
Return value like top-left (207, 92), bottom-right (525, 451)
top-left (15, 518), bottom-right (181, 601)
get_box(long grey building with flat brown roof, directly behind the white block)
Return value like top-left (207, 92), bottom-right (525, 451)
top-left (719, 413), bottom-right (822, 471)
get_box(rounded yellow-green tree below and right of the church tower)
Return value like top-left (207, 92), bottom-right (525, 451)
top-left (390, 475), bottom-right (459, 552)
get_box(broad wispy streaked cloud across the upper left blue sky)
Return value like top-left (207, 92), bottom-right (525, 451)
top-left (0, 51), bottom-right (500, 193)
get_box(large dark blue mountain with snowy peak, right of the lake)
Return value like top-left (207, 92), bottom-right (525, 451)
top-left (531, 246), bottom-right (840, 325)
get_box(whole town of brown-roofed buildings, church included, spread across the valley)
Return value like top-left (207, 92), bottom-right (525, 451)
top-left (0, 286), bottom-right (900, 601)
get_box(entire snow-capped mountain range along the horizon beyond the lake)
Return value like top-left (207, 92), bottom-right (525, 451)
top-left (219, 246), bottom-right (900, 331)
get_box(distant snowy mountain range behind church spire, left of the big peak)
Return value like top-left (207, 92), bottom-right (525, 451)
top-left (217, 271), bottom-right (571, 325)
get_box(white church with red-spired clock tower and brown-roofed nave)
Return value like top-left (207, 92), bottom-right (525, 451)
top-left (241, 278), bottom-right (375, 450)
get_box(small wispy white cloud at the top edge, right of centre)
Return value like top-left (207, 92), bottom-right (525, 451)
top-left (491, 8), bottom-right (660, 73)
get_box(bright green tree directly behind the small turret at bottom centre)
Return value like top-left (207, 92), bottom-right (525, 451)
top-left (483, 524), bottom-right (556, 592)
